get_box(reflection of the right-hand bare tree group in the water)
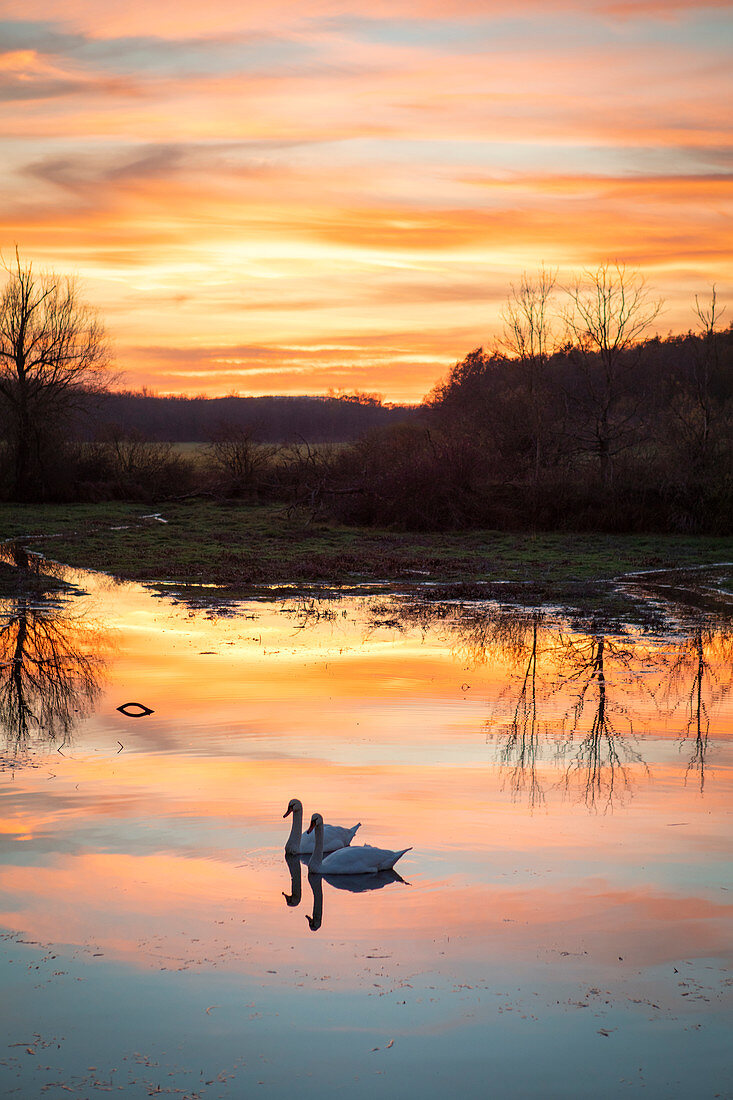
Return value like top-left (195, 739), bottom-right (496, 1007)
top-left (374, 603), bottom-right (733, 810)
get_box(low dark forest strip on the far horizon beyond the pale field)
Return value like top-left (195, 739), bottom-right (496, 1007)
top-left (76, 392), bottom-right (414, 443)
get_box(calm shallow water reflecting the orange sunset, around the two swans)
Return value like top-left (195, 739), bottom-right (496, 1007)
top-left (0, 575), bottom-right (733, 1100)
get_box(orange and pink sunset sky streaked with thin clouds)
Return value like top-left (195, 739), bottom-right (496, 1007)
top-left (0, 0), bottom-right (733, 402)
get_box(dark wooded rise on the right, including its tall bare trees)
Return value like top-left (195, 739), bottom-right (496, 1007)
top-left (337, 264), bottom-right (733, 534)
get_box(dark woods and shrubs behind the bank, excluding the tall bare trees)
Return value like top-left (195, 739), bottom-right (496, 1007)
top-left (0, 327), bottom-right (733, 534)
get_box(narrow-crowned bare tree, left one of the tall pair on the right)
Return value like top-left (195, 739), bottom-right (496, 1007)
top-left (500, 265), bottom-right (557, 485)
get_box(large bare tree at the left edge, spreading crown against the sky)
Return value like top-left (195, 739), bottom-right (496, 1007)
top-left (0, 249), bottom-right (109, 499)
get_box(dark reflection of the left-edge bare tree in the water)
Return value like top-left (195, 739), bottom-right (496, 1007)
top-left (0, 547), bottom-right (105, 765)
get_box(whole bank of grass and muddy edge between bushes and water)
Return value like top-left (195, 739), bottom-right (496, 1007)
top-left (0, 504), bottom-right (733, 623)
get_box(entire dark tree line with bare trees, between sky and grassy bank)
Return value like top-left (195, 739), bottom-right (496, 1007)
top-left (0, 254), bottom-right (733, 534)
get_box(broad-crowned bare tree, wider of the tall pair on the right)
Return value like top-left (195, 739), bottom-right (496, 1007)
top-left (564, 263), bottom-right (663, 488)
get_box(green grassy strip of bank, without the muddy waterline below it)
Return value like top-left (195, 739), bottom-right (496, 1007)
top-left (0, 501), bottom-right (733, 594)
